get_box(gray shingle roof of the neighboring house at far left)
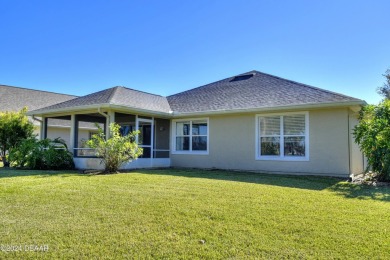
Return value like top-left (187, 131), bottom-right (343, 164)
top-left (0, 85), bottom-right (77, 111)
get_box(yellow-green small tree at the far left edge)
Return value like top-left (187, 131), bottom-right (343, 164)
top-left (0, 108), bottom-right (34, 166)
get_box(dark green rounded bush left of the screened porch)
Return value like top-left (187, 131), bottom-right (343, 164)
top-left (9, 138), bottom-right (74, 170)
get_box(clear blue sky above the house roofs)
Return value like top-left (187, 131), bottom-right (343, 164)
top-left (0, 0), bottom-right (390, 103)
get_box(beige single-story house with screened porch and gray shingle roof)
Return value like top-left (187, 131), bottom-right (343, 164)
top-left (29, 71), bottom-right (365, 177)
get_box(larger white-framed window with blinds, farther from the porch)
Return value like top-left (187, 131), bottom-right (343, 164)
top-left (256, 113), bottom-right (309, 160)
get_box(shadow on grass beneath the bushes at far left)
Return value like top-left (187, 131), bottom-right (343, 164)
top-left (0, 168), bottom-right (81, 179)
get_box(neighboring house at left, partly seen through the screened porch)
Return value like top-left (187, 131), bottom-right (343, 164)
top-left (0, 85), bottom-right (97, 146)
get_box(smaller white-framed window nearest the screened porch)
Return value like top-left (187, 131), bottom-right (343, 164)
top-left (172, 119), bottom-right (209, 154)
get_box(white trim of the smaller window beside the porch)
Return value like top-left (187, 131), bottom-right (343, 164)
top-left (171, 117), bottom-right (210, 155)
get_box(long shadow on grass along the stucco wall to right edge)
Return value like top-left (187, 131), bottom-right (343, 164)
top-left (137, 169), bottom-right (390, 201)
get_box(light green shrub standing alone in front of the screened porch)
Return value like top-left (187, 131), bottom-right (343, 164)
top-left (86, 123), bottom-right (142, 173)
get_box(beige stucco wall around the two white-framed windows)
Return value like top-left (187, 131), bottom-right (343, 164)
top-left (171, 108), bottom-right (359, 177)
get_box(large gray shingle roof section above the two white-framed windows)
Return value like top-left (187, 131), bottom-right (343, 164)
top-left (167, 71), bottom-right (363, 113)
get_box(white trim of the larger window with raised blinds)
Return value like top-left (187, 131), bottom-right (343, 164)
top-left (255, 111), bottom-right (310, 161)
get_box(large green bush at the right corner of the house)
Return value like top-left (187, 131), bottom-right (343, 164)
top-left (354, 99), bottom-right (390, 181)
